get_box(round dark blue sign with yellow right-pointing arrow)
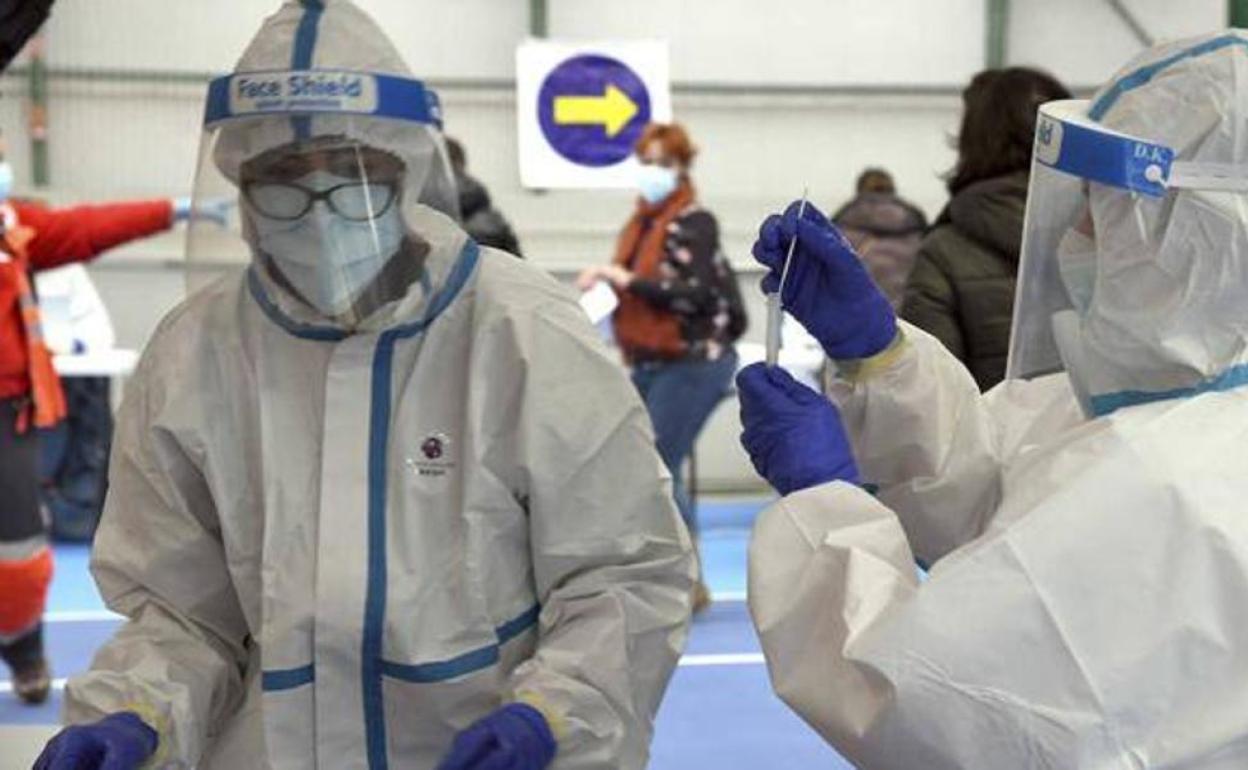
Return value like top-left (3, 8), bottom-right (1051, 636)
top-left (538, 54), bottom-right (650, 167)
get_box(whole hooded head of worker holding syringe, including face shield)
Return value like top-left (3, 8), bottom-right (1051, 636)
top-left (1007, 31), bottom-right (1248, 416)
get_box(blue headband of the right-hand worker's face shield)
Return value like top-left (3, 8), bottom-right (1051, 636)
top-left (1036, 110), bottom-right (1174, 197)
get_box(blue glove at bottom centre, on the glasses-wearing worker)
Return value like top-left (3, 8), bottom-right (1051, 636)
top-left (438, 703), bottom-right (555, 770)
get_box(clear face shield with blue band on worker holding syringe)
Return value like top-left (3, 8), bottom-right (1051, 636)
top-left (1006, 100), bottom-right (1248, 396)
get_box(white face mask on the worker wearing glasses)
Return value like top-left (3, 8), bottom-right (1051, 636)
top-left (251, 171), bottom-right (406, 317)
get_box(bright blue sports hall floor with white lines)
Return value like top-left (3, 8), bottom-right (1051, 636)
top-left (0, 499), bottom-right (851, 770)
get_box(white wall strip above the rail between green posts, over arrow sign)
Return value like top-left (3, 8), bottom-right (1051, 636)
top-left (550, 0), bottom-right (983, 86)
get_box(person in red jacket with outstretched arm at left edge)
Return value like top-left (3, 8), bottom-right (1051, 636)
top-left (0, 132), bottom-right (190, 704)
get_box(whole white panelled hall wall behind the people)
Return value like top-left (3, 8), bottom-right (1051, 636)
top-left (0, 0), bottom-right (1226, 485)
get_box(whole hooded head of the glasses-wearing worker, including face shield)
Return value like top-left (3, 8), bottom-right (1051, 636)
top-left (187, 0), bottom-right (469, 332)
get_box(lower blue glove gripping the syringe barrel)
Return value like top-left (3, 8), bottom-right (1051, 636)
top-left (736, 363), bottom-right (859, 494)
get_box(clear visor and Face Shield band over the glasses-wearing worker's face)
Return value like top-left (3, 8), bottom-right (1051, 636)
top-left (187, 70), bottom-right (459, 327)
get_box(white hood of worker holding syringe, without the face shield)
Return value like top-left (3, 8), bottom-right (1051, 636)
top-left (1080, 31), bottom-right (1248, 412)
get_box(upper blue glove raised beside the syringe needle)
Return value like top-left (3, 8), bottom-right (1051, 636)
top-left (754, 203), bottom-right (897, 361)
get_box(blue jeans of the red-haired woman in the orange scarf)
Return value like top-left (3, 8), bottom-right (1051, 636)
top-left (633, 348), bottom-right (736, 534)
